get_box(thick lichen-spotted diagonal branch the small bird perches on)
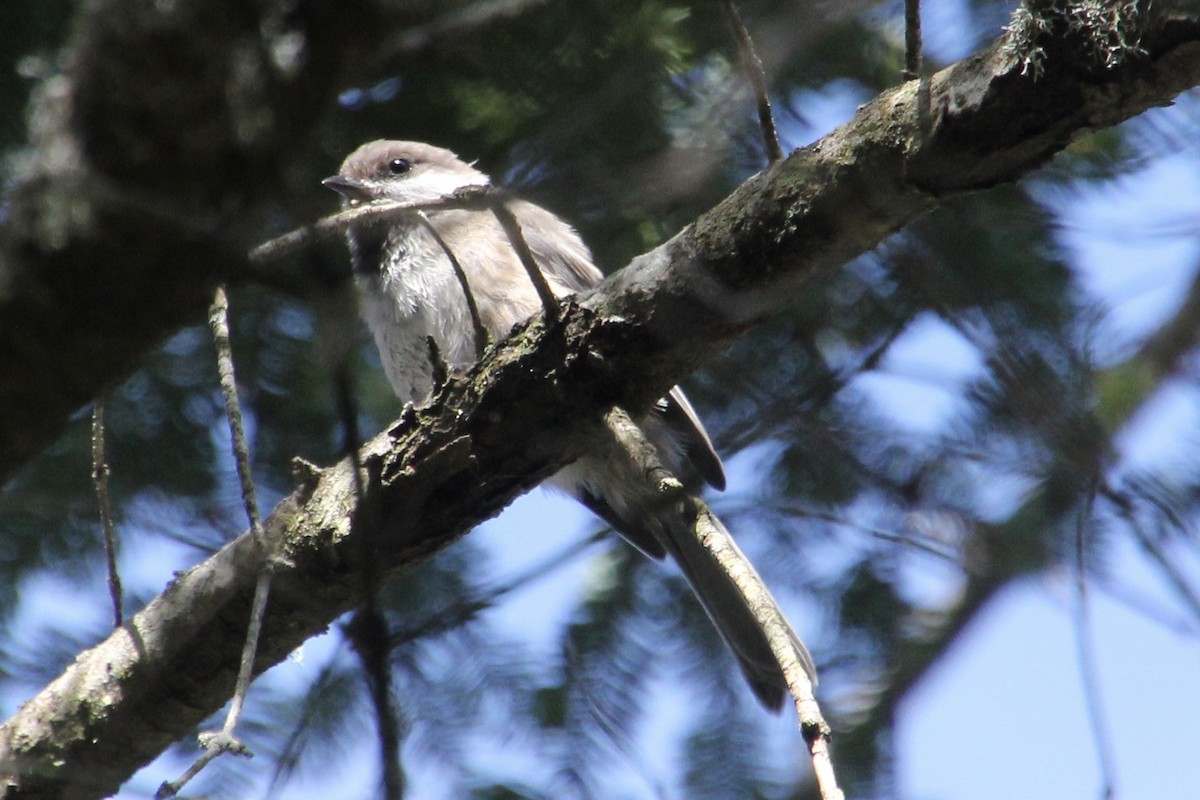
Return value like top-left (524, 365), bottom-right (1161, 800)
top-left (0, 4), bottom-right (1200, 798)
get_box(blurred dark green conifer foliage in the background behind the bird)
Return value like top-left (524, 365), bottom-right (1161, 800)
top-left (0, 0), bottom-right (1200, 800)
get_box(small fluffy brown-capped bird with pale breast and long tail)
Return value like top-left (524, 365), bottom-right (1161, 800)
top-left (322, 139), bottom-right (817, 711)
